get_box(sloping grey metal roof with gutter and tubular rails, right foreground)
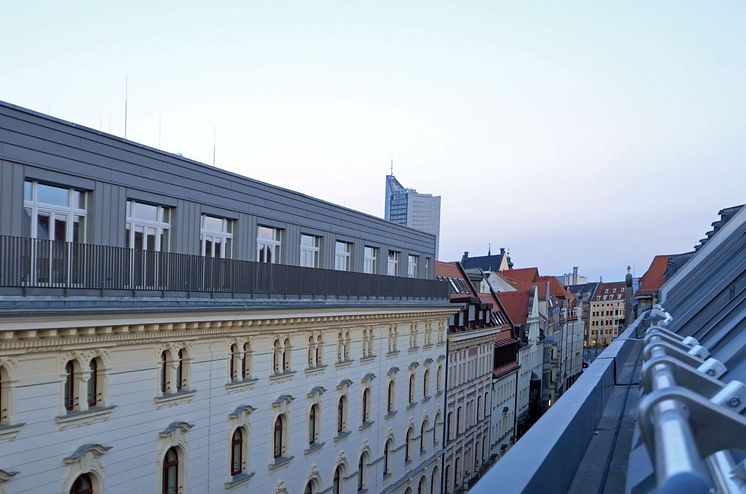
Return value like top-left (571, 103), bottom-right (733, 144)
top-left (470, 207), bottom-right (746, 494)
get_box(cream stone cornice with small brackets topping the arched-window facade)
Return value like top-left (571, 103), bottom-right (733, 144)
top-left (0, 308), bottom-right (450, 351)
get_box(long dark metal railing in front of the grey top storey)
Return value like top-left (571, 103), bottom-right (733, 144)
top-left (0, 236), bottom-right (449, 299)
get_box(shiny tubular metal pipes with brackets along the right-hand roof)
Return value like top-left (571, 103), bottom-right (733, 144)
top-left (638, 307), bottom-right (746, 494)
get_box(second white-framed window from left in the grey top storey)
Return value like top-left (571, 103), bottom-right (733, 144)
top-left (125, 200), bottom-right (171, 252)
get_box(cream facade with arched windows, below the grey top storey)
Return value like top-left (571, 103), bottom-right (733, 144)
top-left (0, 307), bottom-right (450, 494)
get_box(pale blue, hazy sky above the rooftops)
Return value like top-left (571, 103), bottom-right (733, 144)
top-left (0, 0), bottom-right (746, 281)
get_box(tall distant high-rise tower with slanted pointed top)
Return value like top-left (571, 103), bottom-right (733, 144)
top-left (384, 174), bottom-right (440, 259)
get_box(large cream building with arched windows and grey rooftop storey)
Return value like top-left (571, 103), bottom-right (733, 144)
top-left (0, 102), bottom-right (455, 494)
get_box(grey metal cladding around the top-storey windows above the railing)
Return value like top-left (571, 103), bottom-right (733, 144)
top-left (0, 102), bottom-right (436, 279)
